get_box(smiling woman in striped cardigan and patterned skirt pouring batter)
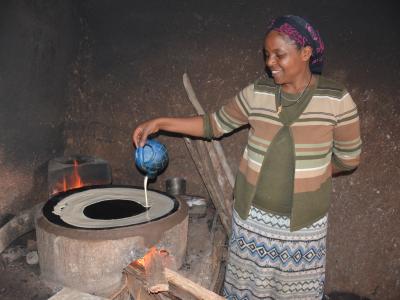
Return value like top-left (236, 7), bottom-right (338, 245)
top-left (133, 15), bottom-right (361, 299)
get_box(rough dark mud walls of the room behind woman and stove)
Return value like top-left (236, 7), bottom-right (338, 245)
top-left (0, 0), bottom-right (400, 299)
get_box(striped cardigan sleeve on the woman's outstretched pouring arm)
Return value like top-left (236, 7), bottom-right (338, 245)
top-left (203, 86), bottom-right (253, 139)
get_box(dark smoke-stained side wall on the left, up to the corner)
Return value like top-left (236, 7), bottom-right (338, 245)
top-left (0, 0), bottom-right (79, 217)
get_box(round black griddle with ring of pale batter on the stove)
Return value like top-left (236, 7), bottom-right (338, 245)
top-left (43, 186), bottom-right (179, 230)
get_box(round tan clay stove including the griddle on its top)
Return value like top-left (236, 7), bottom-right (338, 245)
top-left (36, 158), bottom-right (188, 296)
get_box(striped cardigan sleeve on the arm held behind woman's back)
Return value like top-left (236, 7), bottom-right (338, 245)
top-left (332, 92), bottom-right (361, 171)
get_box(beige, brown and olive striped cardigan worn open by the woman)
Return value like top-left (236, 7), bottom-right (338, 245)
top-left (204, 76), bottom-right (361, 231)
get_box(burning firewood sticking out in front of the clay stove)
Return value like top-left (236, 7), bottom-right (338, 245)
top-left (125, 248), bottom-right (224, 300)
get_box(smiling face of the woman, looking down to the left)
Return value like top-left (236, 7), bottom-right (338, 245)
top-left (264, 31), bottom-right (312, 84)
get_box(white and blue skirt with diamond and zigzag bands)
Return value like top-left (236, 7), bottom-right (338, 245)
top-left (223, 207), bottom-right (328, 300)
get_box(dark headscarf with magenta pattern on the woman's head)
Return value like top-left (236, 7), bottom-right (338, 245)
top-left (267, 15), bottom-right (325, 74)
